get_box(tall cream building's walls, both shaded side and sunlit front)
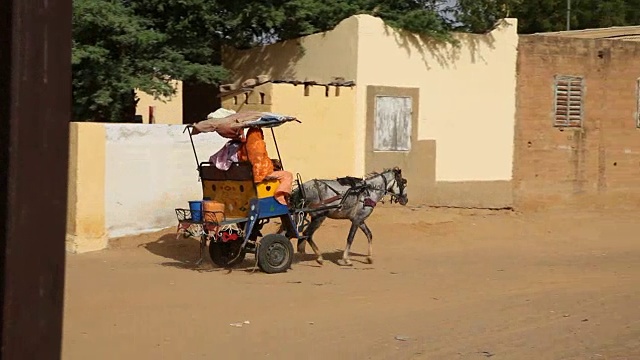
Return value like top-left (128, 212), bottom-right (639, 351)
top-left (223, 15), bottom-right (518, 182)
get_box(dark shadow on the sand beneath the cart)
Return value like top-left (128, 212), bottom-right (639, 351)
top-left (140, 234), bottom-right (315, 274)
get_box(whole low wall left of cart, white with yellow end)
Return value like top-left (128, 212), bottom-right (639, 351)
top-left (67, 123), bottom-right (225, 253)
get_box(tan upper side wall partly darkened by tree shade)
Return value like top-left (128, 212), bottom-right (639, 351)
top-left (223, 17), bottom-right (358, 84)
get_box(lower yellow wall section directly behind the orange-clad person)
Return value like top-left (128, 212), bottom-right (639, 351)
top-left (265, 84), bottom-right (361, 181)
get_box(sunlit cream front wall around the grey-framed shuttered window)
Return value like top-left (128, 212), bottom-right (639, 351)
top-left (354, 15), bottom-right (518, 182)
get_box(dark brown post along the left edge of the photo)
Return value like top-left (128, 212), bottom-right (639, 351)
top-left (0, 0), bottom-right (72, 360)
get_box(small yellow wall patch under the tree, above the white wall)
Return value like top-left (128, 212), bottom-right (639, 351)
top-left (136, 81), bottom-right (182, 124)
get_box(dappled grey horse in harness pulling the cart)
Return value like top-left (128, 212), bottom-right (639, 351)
top-left (291, 167), bottom-right (408, 265)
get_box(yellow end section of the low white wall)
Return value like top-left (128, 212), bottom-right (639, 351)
top-left (66, 122), bottom-right (107, 253)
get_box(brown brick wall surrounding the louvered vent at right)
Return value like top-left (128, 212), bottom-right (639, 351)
top-left (513, 35), bottom-right (640, 208)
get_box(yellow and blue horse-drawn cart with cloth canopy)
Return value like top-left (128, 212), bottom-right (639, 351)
top-left (175, 113), bottom-right (341, 273)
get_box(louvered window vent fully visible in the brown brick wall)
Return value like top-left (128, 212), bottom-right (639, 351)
top-left (553, 76), bottom-right (584, 127)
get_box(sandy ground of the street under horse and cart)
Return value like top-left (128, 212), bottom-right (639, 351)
top-left (63, 207), bottom-right (640, 360)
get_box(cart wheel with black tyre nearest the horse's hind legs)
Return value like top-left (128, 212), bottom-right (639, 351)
top-left (256, 234), bottom-right (293, 274)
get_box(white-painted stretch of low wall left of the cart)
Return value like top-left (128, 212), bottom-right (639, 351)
top-left (105, 124), bottom-right (226, 238)
